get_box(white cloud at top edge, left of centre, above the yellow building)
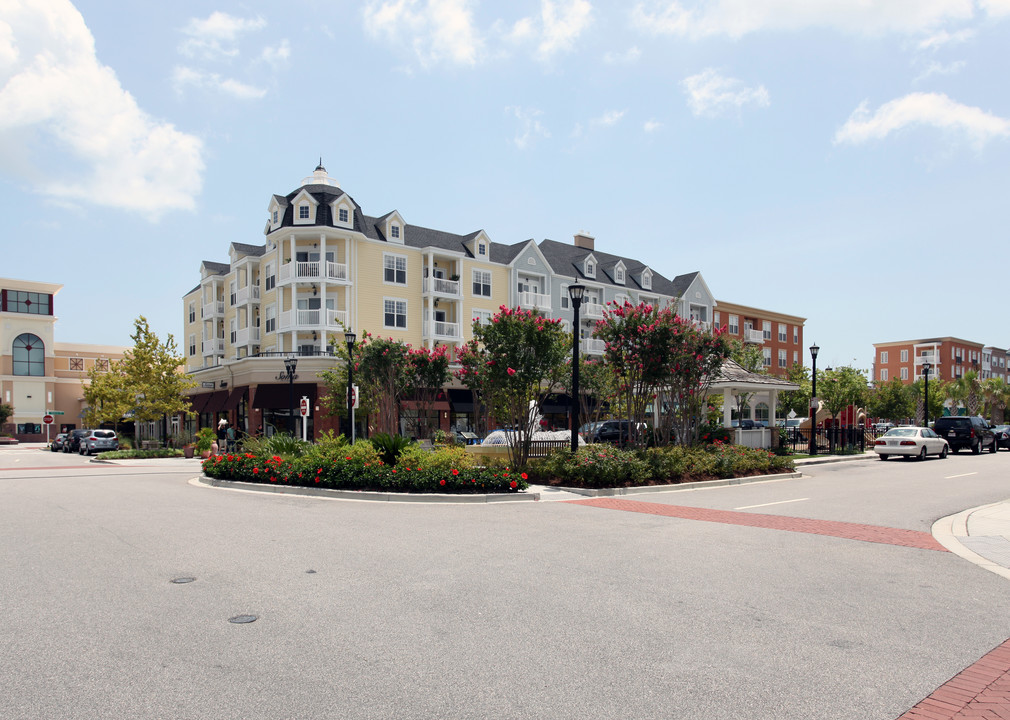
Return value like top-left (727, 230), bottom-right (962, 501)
top-left (365, 0), bottom-right (484, 67)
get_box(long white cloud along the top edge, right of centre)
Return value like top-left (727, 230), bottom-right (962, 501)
top-left (631, 0), bottom-right (977, 37)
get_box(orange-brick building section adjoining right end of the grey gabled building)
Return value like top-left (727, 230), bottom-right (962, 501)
top-left (714, 300), bottom-right (806, 377)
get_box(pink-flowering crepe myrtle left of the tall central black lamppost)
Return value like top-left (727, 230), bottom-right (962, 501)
top-left (457, 305), bottom-right (572, 470)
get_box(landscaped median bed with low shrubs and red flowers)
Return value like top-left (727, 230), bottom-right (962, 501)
top-left (203, 432), bottom-right (794, 495)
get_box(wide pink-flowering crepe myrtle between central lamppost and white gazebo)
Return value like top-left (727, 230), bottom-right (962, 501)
top-left (596, 302), bottom-right (729, 445)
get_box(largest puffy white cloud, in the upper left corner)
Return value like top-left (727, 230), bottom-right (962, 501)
top-left (0, 0), bottom-right (204, 218)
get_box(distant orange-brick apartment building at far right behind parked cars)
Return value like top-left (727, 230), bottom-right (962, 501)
top-left (873, 336), bottom-right (989, 385)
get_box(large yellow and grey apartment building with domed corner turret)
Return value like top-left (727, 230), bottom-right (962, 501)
top-left (183, 165), bottom-right (714, 434)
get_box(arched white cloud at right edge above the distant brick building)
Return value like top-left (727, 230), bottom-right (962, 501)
top-left (834, 93), bottom-right (1010, 148)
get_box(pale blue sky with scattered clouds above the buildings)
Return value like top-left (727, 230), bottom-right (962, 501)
top-left (0, 0), bottom-right (1010, 368)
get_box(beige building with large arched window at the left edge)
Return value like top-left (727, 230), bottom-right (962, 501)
top-left (0, 278), bottom-right (126, 442)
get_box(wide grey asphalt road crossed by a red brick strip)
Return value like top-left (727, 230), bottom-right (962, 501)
top-left (0, 448), bottom-right (1010, 720)
